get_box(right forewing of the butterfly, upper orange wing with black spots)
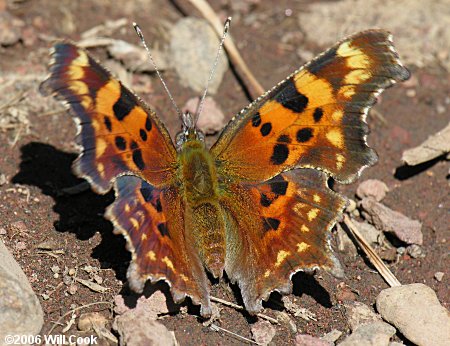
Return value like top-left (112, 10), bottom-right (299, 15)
top-left (211, 30), bottom-right (409, 182)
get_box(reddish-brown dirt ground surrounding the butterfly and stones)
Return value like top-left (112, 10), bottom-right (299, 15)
top-left (0, 0), bottom-right (450, 345)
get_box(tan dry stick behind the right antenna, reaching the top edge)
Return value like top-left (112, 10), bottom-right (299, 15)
top-left (189, 0), bottom-right (264, 99)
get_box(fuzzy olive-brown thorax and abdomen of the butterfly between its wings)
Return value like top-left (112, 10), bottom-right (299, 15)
top-left (178, 138), bottom-right (225, 277)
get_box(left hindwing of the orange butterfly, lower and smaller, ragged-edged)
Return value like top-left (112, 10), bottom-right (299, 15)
top-left (105, 175), bottom-right (211, 316)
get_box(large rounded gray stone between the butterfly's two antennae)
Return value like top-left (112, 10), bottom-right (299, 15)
top-left (170, 18), bottom-right (228, 94)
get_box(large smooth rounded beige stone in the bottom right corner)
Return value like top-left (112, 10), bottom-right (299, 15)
top-left (377, 283), bottom-right (450, 346)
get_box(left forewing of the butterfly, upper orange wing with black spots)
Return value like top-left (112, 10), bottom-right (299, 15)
top-left (43, 42), bottom-right (176, 193)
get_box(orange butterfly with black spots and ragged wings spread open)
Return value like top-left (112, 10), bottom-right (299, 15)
top-left (43, 30), bottom-right (409, 316)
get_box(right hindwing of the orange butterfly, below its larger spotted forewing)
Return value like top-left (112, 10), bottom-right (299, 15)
top-left (221, 169), bottom-right (346, 313)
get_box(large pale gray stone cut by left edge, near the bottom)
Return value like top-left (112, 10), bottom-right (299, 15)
top-left (0, 240), bottom-right (44, 336)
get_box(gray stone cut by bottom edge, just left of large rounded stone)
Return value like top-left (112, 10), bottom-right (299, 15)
top-left (339, 321), bottom-right (395, 346)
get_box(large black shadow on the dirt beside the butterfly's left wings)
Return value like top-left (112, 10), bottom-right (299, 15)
top-left (12, 142), bottom-right (131, 280)
